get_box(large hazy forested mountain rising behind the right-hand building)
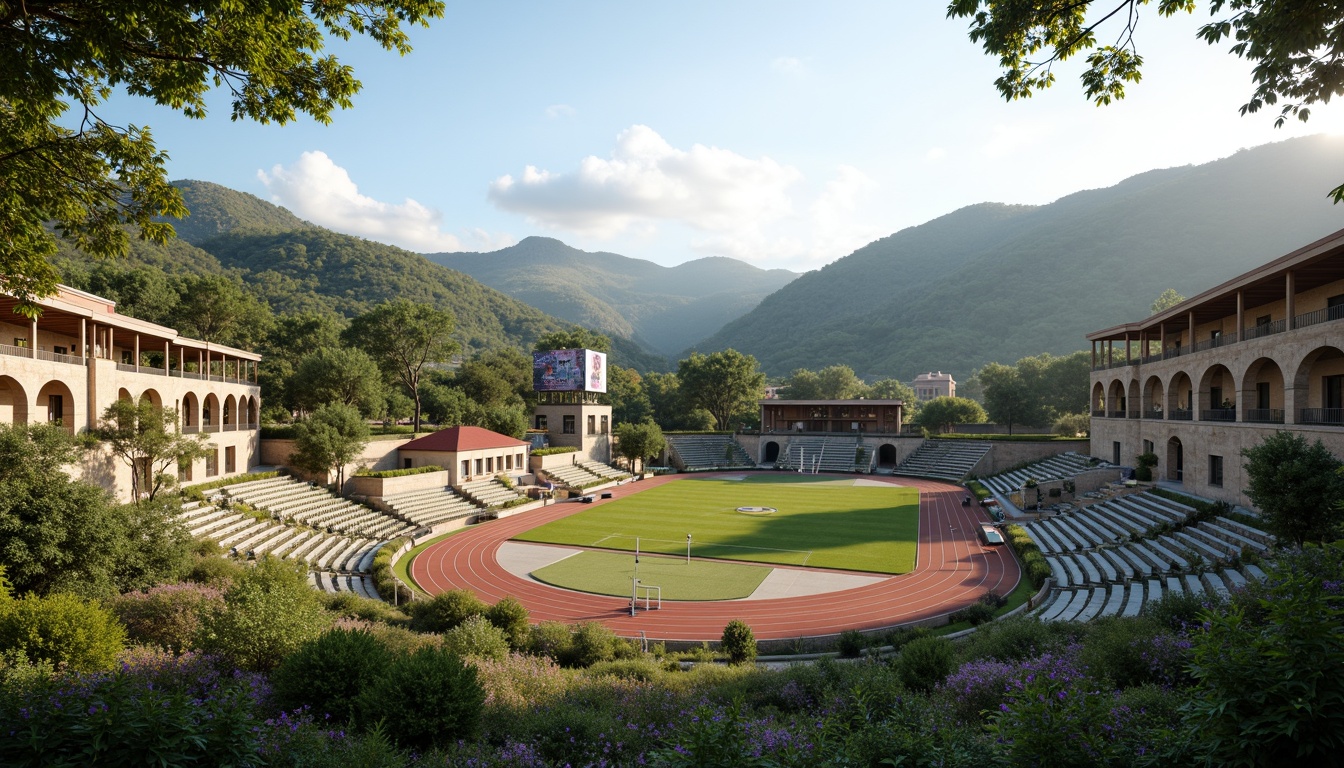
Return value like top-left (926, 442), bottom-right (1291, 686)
top-left (696, 136), bottom-right (1344, 379)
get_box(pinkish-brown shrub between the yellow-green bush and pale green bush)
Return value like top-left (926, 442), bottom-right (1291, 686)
top-left (112, 582), bottom-right (224, 654)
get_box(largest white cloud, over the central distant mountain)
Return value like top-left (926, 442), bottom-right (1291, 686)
top-left (489, 125), bottom-right (802, 237)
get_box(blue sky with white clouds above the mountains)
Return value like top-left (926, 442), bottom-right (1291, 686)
top-left (105, 0), bottom-right (1344, 270)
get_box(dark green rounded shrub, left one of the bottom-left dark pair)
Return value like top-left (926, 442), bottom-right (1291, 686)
top-left (270, 629), bottom-right (392, 722)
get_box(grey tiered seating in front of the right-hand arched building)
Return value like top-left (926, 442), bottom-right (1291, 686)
top-left (1023, 494), bottom-right (1273, 621)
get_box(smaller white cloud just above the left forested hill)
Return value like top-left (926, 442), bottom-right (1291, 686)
top-left (257, 151), bottom-right (513, 253)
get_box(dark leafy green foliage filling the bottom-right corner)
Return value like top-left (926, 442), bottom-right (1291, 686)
top-left (1191, 546), bottom-right (1344, 765)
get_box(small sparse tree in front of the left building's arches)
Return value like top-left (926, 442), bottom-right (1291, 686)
top-left (93, 399), bottom-right (210, 502)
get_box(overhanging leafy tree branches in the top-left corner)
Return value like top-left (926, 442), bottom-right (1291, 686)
top-left (0, 0), bottom-right (444, 317)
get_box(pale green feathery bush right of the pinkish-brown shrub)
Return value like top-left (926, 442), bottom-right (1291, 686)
top-left (196, 557), bottom-right (331, 670)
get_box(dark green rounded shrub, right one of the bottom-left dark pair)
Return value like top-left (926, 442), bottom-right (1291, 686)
top-left (358, 648), bottom-right (485, 751)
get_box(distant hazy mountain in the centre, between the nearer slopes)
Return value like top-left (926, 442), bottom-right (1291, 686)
top-left (429, 237), bottom-right (797, 355)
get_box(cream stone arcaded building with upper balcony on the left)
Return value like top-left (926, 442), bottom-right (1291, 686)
top-left (0, 285), bottom-right (261, 500)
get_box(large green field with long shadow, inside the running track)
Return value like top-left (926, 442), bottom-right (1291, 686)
top-left (515, 475), bottom-right (919, 573)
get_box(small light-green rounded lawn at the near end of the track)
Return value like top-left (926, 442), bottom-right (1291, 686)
top-left (532, 551), bottom-right (771, 605)
